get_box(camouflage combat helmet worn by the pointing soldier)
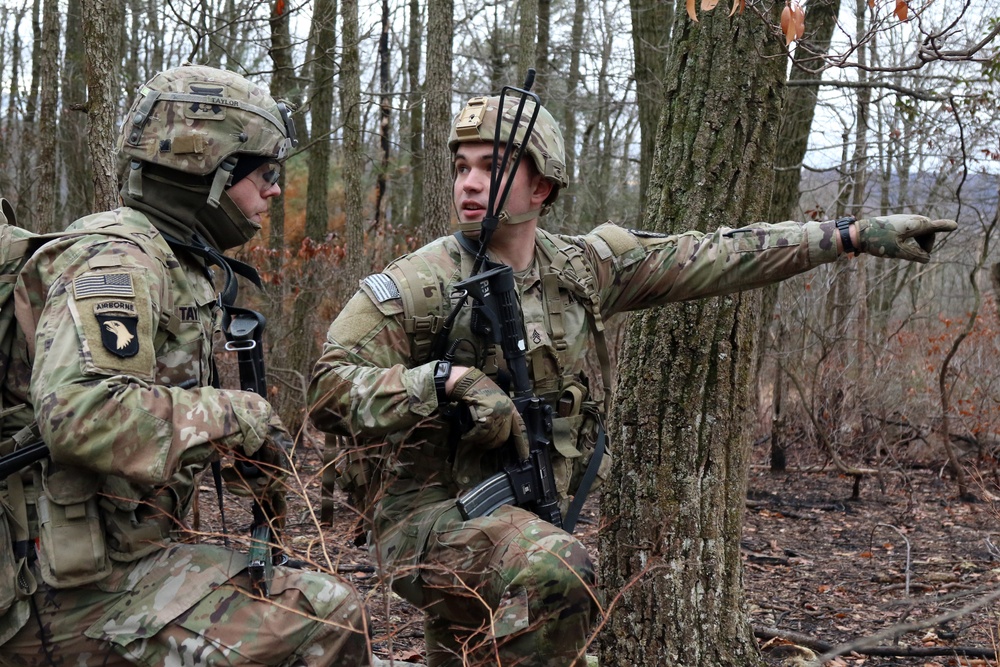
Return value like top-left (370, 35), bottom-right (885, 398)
top-left (448, 95), bottom-right (569, 222)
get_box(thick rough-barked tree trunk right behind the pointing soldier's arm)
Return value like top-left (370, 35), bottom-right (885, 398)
top-left (601, 9), bottom-right (785, 667)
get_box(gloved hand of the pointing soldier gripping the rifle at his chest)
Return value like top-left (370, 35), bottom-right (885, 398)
top-left (451, 368), bottom-right (526, 449)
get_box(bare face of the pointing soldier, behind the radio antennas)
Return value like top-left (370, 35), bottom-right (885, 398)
top-left (453, 141), bottom-right (552, 227)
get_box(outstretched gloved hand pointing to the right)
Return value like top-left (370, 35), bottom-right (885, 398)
top-left (855, 214), bottom-right (958, 264)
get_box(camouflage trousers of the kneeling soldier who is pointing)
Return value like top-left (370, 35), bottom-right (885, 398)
top-left (370, 488), bottom-right (598, 667)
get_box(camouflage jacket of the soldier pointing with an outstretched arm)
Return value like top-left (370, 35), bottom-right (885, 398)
top-left (309, 222), bottom-right (839, 506)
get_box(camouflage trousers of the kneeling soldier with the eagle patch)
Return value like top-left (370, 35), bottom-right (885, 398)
top-left (0, 544), bottom-right (371, 667)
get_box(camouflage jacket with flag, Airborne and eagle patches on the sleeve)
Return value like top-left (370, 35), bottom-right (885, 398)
top-left (3, 208), bottom-right (271, 561)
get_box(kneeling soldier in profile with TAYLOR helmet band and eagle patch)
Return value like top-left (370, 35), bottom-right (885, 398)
top-left (0, 66), bottom-right (371, 666)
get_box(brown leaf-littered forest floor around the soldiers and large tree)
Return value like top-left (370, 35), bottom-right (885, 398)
top-left (209, 439), bottom-right (1000, 667)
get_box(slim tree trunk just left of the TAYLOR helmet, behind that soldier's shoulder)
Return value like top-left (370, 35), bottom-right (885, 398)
top-left (83, 0), bottom-right (125, 211)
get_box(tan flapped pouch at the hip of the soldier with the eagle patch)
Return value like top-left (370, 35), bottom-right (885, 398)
top-left (35, 465), bottom-right (111, 588)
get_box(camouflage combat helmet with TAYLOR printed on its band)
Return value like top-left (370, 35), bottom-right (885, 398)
top-left (116, 65), bottom-right (297, 207)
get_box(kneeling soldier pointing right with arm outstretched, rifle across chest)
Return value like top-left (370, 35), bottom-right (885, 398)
top-left (309, 97), bottom-right (955, 666)
